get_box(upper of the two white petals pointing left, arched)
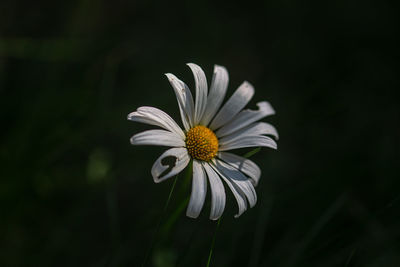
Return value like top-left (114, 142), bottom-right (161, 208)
top-left (128, 107), bottom-right (185, 139)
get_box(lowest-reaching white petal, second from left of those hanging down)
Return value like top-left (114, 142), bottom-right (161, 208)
top-left (202, 162), bottom-right (226, 220)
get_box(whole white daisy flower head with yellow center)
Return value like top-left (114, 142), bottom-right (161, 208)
top-left (128, 63), bottom-right (278, 220)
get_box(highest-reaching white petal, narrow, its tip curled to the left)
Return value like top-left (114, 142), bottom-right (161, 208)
top-left (187, 63), bottom-right (208, 125)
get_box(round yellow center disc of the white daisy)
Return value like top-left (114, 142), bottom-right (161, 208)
top-left (185, 125), bottom-right (218, 161)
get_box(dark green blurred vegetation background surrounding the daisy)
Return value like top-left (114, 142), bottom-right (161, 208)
top-left (0, 0), bottom-right (400, 267)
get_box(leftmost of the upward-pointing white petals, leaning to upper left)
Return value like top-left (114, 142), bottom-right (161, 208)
top-left (165, 73), bottom-right (194, 130)
